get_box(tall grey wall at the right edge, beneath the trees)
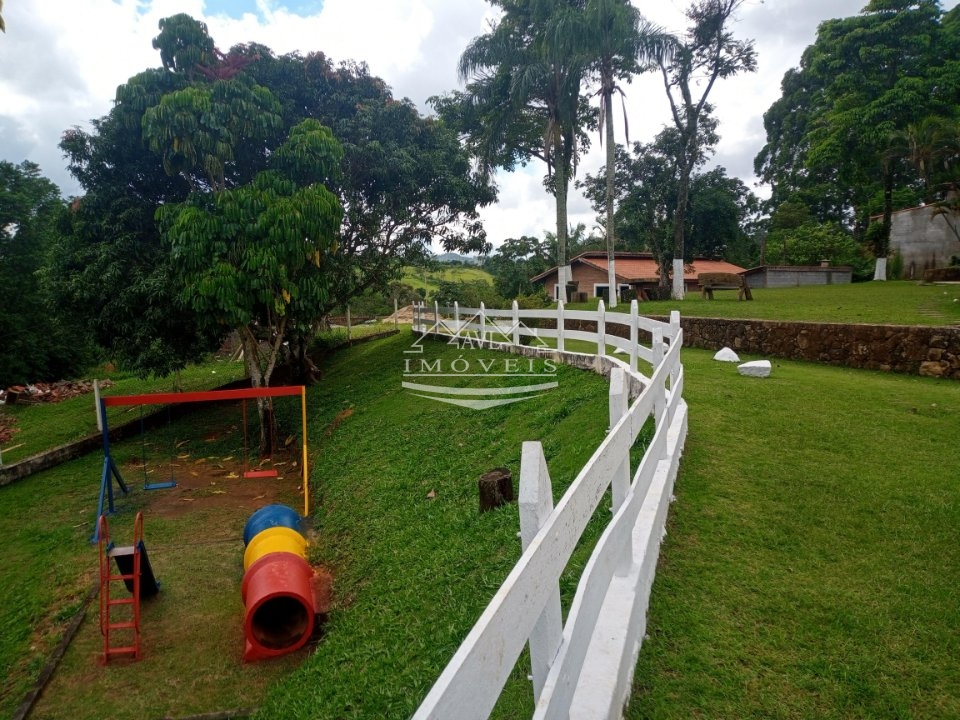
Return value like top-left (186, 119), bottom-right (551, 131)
top-left (890, 206), bottom-right (960, 280)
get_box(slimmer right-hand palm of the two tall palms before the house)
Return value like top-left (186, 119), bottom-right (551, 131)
top-left (584, 0), bottom-right (673, 308)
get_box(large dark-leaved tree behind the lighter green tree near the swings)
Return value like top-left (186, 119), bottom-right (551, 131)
top-left (50, 15), bottom-right (494, 390)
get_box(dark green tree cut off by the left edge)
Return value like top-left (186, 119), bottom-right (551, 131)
top-left (0, 161), bottom-right (90, 387)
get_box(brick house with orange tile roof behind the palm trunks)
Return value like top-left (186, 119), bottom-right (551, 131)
top-left (531, 250), bottom-right (744, 301)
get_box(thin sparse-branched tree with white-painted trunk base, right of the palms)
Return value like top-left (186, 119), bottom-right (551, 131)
top-left (660, 0), bottom-right (757, 299)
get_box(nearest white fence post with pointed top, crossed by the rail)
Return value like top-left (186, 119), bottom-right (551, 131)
top-left (519, 442), bottom-right (563, 702)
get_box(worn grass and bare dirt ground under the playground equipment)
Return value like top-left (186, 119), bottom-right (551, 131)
top-left (9, 398), bottom-right (331, 720)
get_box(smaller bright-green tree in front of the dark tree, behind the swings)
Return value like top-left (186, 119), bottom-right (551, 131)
top-left (154, 120), bottom-right (342, 402)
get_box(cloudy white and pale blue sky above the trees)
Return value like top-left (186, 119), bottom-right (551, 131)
top-left (0, 0), bottom-right (960, 244)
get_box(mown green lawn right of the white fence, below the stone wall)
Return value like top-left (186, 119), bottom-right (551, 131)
top-left (627, 351), bottom-right (960, 719)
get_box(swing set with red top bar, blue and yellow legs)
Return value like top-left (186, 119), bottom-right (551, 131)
top-left (91, 385), bottom-right (310, 542)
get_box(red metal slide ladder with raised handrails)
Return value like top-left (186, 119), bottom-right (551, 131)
top-left (99, 513), bottom-right (143, 664)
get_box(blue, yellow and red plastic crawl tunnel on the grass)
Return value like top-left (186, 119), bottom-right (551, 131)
top-left (240, 505), bottom-right (317, 662)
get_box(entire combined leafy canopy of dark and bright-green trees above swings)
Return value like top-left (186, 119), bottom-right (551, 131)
top-left (50, 14), bottom-right (495, 380)
